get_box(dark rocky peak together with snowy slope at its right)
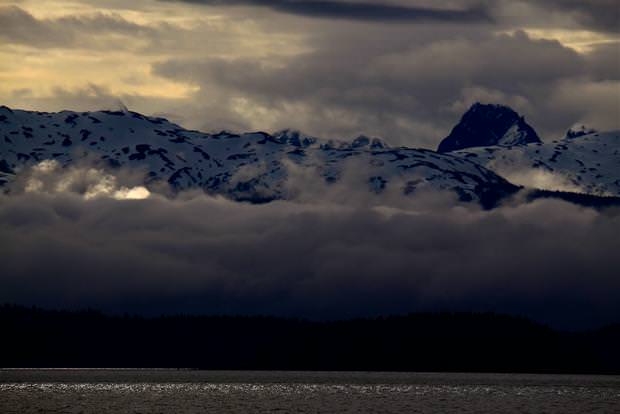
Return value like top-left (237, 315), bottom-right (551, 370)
top-left (439, 103), bottom-right (620, 197)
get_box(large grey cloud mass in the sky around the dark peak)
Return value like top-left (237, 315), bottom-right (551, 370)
top-left (154, 28), bottom-right (620, 147)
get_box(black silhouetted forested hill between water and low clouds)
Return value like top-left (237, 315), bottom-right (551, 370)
top-left (0, 305), bottom-right (620, 373)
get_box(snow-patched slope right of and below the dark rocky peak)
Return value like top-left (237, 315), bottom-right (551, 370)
top-left (452, 128), bottom-right (620, 197)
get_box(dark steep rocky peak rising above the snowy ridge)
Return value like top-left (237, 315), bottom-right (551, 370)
top-left (437, 103), bottom-right (542, 153)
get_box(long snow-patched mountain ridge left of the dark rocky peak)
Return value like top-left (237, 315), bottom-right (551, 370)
top-left (0, 107), bottom-right (518, 206)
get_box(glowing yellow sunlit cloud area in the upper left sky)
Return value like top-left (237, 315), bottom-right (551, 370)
top-left (0, 0), bottom-right (307, 113)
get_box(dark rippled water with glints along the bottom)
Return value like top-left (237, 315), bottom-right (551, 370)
top-left (0, 370), bottom-right (620, 414)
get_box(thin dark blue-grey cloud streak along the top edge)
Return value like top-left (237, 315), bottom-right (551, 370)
top-left (164, 0), bottom-right (491, 23)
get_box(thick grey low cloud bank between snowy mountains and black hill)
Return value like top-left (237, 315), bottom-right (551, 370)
top-left (0, 165), bottom-right (620, 328)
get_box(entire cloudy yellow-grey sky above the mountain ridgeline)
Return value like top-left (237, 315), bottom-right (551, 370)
top-left (0, 0), bottom-right (620, 148)
